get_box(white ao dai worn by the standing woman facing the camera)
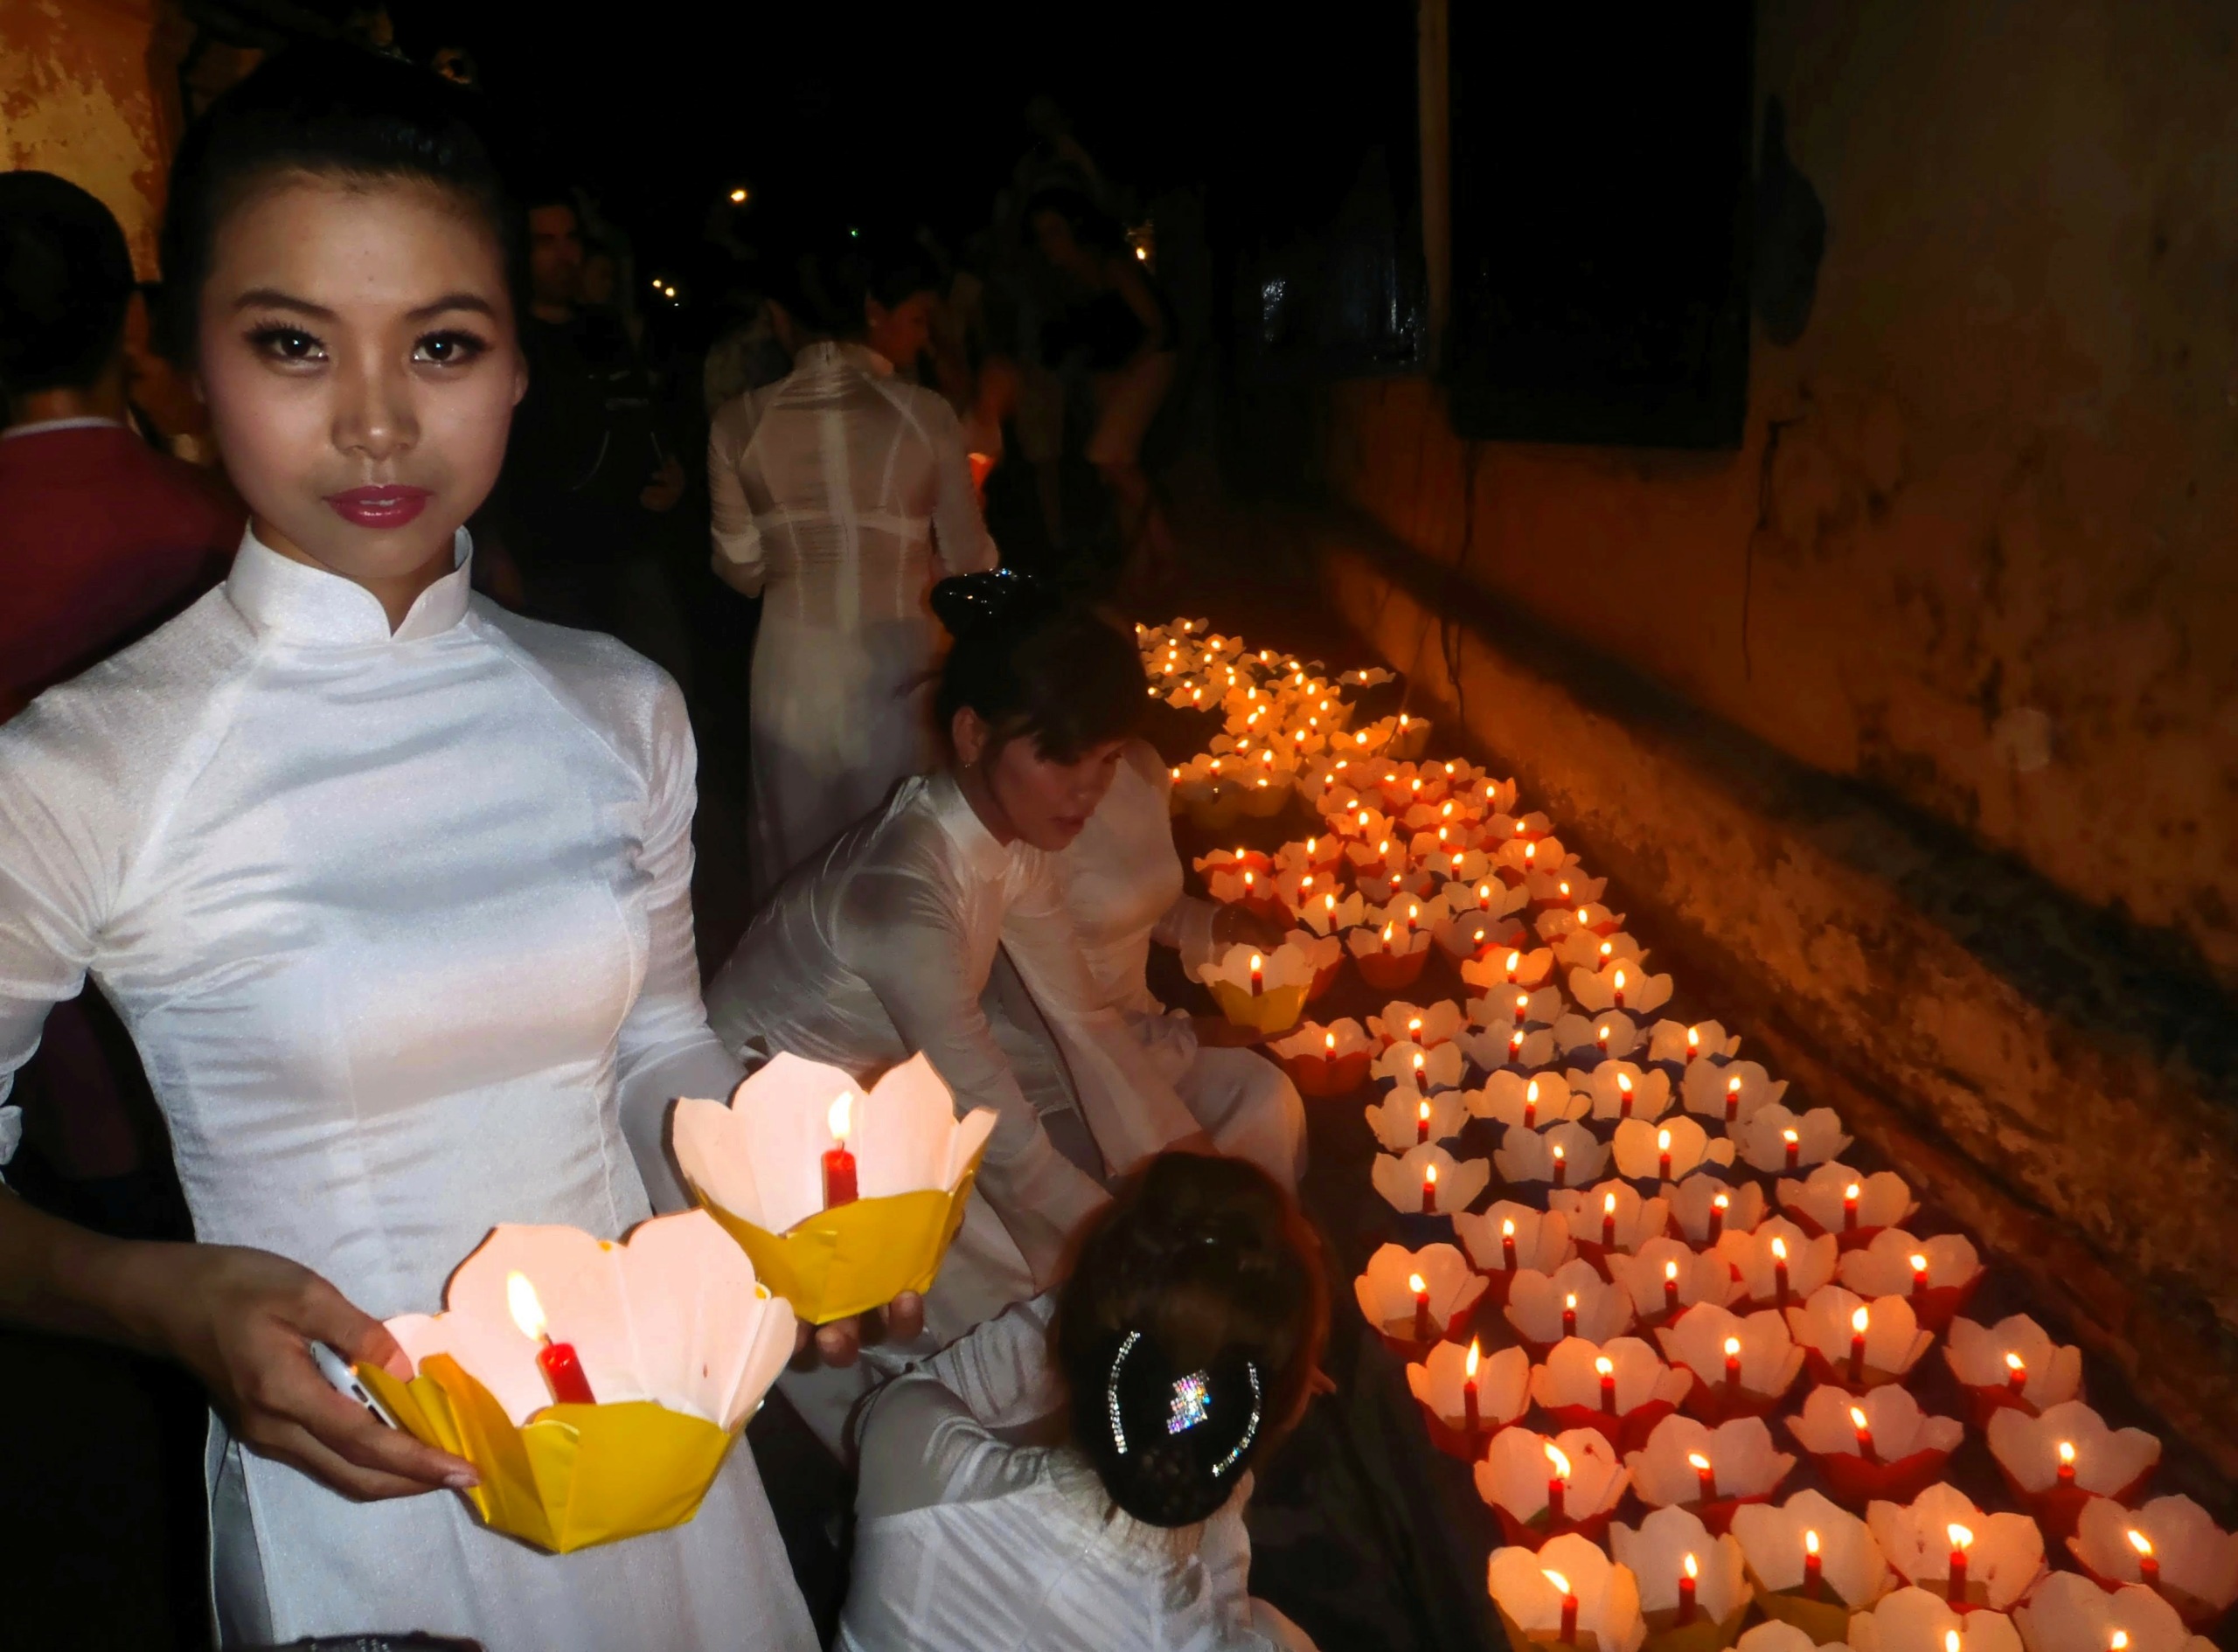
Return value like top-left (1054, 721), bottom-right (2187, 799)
top-left (0, 533), bottom-right (815, 1652)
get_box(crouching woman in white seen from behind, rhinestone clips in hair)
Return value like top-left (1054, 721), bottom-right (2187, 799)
top-left (839, 1153), bottom-right (1330, 1652)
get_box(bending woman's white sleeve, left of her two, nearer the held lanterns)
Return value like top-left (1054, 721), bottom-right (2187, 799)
top-left (835, 871), bottom-right (1106, 1288)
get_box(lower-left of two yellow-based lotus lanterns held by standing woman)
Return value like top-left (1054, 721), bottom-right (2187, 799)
top-left (358, 1211), bottom-right (792, 1553)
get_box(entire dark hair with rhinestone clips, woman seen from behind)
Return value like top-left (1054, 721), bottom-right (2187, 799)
top-left (1052, 1153), bottom-right (1330, 1527)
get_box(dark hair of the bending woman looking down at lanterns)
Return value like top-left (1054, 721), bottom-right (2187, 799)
top-left (934, 571), bottom-right (1150, 763)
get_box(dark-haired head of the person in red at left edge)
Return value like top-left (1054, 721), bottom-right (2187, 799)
top-left (0, 172), bottom-right (132, 406)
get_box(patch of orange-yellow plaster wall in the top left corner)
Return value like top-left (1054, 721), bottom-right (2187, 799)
top-left (0, 0), bottom-right (165, 278)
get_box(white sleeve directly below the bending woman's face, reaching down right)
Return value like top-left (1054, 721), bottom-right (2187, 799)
top-left (1003, 855), bottom-right (1199, 1173)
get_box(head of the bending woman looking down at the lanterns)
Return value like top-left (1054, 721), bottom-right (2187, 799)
top-left (934, 573), bottom-right (1148, 850)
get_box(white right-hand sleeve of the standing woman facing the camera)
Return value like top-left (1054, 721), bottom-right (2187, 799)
top-left (615, 678), bottom-right (743, 1211)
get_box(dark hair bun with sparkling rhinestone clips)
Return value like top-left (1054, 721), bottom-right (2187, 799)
top-left (1072, 1329), bottom-right (1267, 1527)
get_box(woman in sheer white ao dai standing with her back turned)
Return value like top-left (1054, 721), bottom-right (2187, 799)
top-left (707, 238), bottom-right (996, 905)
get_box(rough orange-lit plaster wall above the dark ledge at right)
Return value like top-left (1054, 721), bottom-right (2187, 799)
top-left (1325, 0), bottom-right (2238, 987)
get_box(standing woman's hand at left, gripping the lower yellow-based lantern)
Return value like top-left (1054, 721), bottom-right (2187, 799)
top-left (129, 1245), bottom-right (479, 1502)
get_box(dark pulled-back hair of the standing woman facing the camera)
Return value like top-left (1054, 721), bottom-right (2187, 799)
top-left (159, 45), bottom-right (528, 364)
